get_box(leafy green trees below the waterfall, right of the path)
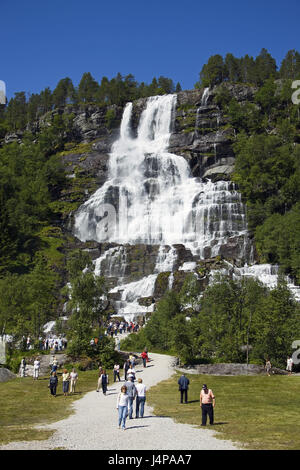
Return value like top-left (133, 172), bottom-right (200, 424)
top-left (122, 276), bottom-right (300, 367)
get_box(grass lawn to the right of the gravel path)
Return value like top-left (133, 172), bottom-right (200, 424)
top-left (148, 374), bottom-right (300, 450)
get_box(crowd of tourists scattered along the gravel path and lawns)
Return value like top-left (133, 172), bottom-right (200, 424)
top-left (20, 328), bottom-right (293, 430)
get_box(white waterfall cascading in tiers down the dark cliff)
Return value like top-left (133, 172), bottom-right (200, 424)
top-left (75, 90), bottom-right (300, 318)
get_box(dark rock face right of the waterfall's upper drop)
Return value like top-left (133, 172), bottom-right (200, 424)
top-left (169, 86), bottom-right (243, 181)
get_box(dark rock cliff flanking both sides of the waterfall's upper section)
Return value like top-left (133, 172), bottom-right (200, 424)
top-left (59, 84), bottom-right (255, 182)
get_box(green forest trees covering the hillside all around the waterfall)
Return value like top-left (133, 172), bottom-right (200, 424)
top-left (0, 49), bottom-right (300, 365)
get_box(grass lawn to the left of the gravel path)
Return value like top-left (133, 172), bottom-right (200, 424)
top-left (0, 370), bottom-right (108, 444)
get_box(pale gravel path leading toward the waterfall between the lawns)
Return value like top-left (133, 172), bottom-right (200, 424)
top-left (0, 354), bottom-right (238, 450)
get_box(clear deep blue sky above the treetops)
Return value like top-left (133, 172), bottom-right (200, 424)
top-left (0, 0), bottom-right (300, 98)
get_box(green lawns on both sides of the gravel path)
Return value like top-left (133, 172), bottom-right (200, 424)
top-left (0, 371), bottom-right (300, 450)
